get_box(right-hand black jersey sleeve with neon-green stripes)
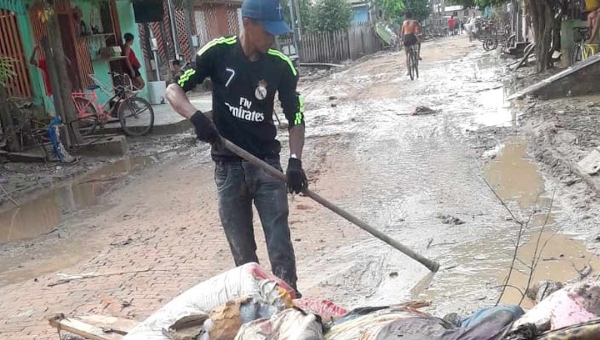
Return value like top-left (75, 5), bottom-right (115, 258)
top-left (276, 51), bottom-right (304, 129)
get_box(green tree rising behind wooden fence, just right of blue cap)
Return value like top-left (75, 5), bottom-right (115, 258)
top-left (310, 0), bottom-right (352, 32)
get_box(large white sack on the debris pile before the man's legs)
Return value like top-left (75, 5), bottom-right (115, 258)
top-left (123, 263), bottom-right (295, 340)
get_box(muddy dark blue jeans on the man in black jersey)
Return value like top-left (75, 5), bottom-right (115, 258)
top-left (215, 159), bottom-right (298, 289)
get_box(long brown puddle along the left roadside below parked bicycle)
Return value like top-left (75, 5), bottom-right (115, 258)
top-left (0, 156), bottom-right (156, 244)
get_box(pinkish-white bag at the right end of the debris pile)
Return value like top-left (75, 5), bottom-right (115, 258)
top-left (514, 281), bottom-right (600, 330)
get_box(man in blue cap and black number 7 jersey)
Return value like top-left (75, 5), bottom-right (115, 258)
top-left (166, 0), bottom-right (308, 289)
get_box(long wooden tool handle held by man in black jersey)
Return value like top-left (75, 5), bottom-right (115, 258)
top-left (221, 137), bottom-right (440, 273)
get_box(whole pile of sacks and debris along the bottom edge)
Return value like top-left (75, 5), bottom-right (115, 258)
top-left (51, 263), bottom-right (600, 340)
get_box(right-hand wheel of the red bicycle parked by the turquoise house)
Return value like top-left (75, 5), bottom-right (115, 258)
top-left (119, 97), bottom-right (154, 137)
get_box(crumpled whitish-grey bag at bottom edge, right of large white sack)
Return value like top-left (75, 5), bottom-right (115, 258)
top-left (235, 308), bottom-right (323, 340)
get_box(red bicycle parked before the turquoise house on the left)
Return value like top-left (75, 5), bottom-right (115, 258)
top-left (71, 72), bottom-right (154, 137)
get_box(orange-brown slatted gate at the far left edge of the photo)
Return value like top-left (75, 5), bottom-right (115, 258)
top-left (0, 9), bottom-right (32, 98)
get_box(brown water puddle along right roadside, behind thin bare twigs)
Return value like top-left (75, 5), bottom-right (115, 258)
top-left (484, 139), bottom-right (600, 308)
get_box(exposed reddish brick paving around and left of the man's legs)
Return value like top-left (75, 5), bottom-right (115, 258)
top-left (0, 137), bottom-right (360, 340)
